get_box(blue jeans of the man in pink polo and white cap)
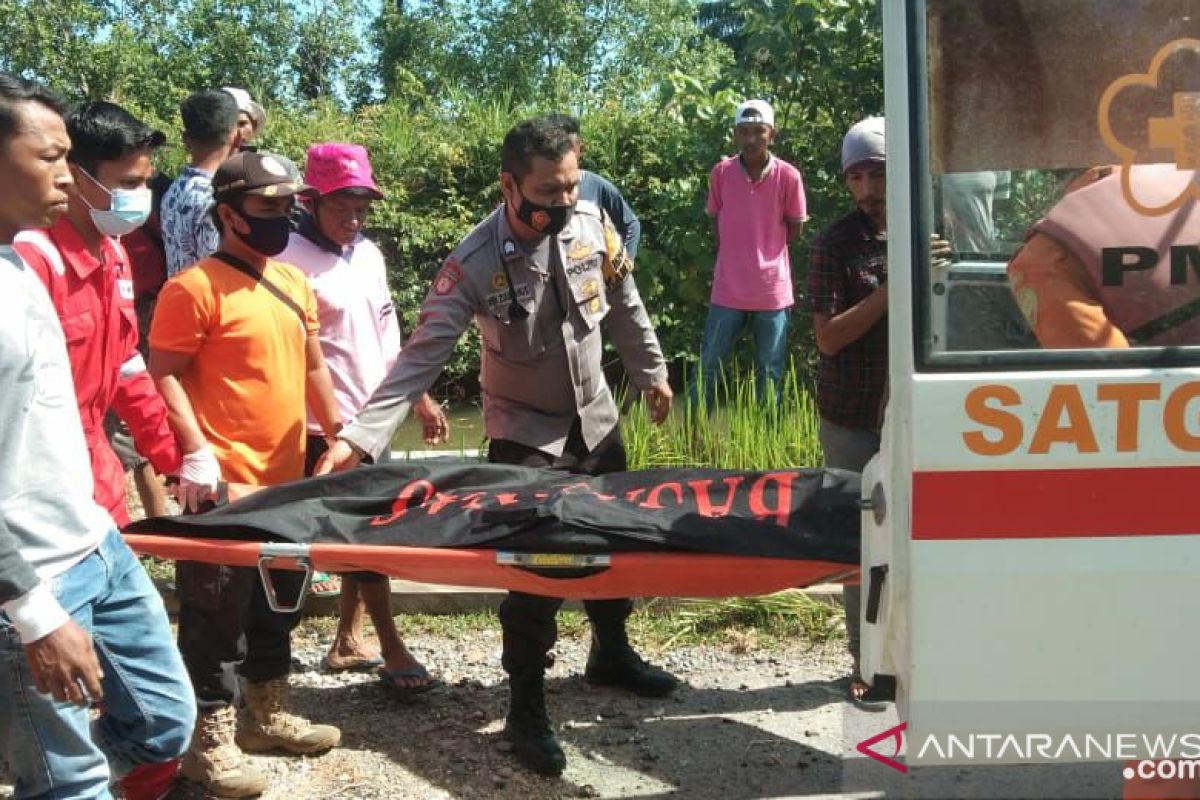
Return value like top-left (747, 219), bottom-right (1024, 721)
top-left (690, 303), bottom-right (792, 409)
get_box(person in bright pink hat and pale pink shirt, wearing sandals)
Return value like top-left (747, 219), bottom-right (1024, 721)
top-left (278, 143), bottom-right (450, 693)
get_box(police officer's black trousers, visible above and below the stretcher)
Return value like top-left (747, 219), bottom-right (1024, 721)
top-left (487, 420), bottom-right (634, 674)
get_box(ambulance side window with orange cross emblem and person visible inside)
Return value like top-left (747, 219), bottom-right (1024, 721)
top-left (910, 0), bottom-right (1200, 368)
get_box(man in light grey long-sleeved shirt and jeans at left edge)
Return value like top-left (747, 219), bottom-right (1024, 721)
top-left (0, 74), bottom-right (196, 798)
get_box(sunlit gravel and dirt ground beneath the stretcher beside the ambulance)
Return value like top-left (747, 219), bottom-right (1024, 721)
top-left (166, 630), bottom-right (864, 800)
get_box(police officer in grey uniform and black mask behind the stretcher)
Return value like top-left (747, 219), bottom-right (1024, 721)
top-left (316, 118), bottom-right (678, 775)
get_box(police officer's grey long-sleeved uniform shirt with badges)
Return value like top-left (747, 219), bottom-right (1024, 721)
top-left (340, 201), bottom-right (667, 456)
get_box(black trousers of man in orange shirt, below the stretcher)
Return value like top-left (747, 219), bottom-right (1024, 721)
top-left (175, 561), bottom-right (306, 711)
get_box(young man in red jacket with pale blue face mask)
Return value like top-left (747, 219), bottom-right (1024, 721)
top-left (14, 102), bottom-right (180, 525)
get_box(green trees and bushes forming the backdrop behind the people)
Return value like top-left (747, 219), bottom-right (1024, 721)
top-left (0, 0), bottom-right (882, 393)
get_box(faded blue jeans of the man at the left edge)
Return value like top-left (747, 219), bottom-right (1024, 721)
top-left (0, 529), bottom-right (196, 798)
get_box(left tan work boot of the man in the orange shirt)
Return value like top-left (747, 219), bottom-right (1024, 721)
top-left (180, 705), bottom-right (266, 798)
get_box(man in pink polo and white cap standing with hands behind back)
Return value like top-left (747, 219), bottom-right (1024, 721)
top-left (691, 100), bottom-right (808, 408)
